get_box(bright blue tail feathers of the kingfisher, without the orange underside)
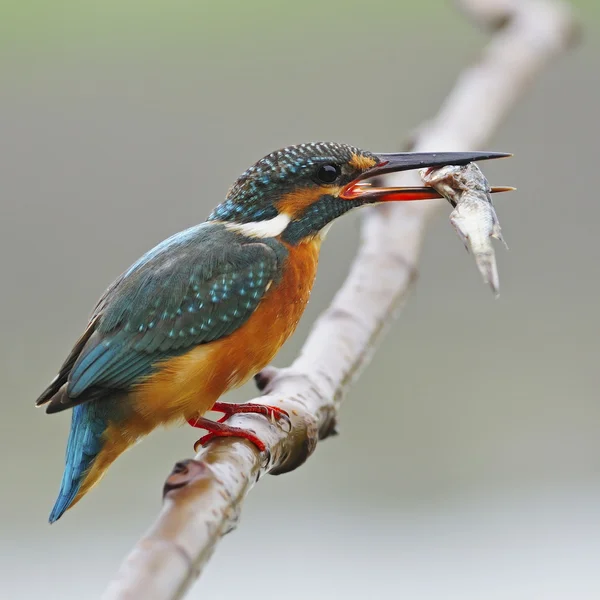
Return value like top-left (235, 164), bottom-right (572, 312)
top-left (49, 401), bottom-right (107, 523)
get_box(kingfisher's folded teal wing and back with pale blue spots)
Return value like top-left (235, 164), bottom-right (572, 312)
top-left (38, 223), bottom-right (287, 412)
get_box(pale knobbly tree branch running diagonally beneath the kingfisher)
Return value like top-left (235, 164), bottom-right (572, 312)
top-left (103, 0), bottom-right (575, 600)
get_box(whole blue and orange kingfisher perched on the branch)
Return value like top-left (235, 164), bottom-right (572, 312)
top-left (36, 142), bottom-right (509, 523)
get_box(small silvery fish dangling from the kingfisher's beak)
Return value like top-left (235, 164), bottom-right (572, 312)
top-left (420, 163), bottom-right (513, 297)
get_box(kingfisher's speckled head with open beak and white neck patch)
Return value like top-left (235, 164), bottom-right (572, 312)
top-left (209, 142), bottom-right (508, 244)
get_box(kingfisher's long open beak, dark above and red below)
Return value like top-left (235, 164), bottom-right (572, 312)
top-left (340, 152), bottom-right (514, 203)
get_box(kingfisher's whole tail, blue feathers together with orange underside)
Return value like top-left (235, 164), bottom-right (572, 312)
top-left (49, 399), bottom-right (134, 523)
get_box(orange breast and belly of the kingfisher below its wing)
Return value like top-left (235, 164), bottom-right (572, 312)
top-left (133, 240), bottom-right (320, 425)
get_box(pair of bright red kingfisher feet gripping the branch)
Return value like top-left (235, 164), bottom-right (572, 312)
top-left (188, 402), bottom-right (290, 452)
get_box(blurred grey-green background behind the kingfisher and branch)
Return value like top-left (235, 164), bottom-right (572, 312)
top-left (0, 0), bottom-right (600, 600)
